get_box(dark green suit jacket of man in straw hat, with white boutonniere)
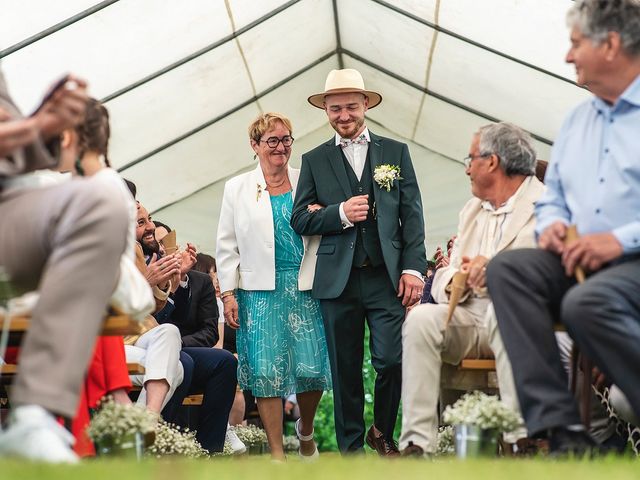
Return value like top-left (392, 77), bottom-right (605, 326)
top-left (291, 132), bottom-right (427, 299)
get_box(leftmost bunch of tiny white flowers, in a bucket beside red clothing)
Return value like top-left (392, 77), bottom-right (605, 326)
top-left (87, 397), bottom-right (157, 445)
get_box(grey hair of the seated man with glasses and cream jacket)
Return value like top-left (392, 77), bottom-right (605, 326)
top-left (476, 122), bottom-right (536, 177)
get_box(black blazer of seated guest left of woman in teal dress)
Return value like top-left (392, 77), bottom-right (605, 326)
top-left (158, 270), bottom-right (219, 347)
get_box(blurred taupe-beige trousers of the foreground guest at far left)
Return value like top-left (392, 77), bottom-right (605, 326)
top-left (0, 178), bottom-right (129, 417)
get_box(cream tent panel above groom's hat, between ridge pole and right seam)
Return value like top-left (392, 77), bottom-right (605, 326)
top-left (338, 0), bottom-right (434, 86)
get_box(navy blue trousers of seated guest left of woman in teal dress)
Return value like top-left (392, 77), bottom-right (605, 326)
top-left (162, 347), bottom-right (238, 452)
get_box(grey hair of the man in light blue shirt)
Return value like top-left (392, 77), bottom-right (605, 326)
top-left (567, 0), bottom-right (640, 57)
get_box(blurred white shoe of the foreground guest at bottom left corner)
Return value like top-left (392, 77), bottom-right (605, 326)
top-left (0, 405), bottom-right (78, 463)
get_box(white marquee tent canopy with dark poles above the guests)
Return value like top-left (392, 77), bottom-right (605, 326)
top-left (0, 0), bottom-right (588, 253)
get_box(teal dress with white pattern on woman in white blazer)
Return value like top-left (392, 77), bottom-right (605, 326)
top-left (237, 192), bottom-right (331, 397)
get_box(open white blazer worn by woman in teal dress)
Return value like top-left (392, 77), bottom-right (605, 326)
top-left (216, 164), bottom-right (320, 292)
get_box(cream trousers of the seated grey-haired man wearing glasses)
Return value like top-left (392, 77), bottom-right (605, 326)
top-left (400, 298), bottom-right (526, 453)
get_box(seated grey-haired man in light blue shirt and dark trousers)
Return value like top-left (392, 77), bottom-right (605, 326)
top-left (487, 0), bottom-right (640, 454)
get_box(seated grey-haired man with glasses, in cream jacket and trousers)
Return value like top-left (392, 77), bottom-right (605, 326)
top-left (400, 123), bottom-right (544, 456)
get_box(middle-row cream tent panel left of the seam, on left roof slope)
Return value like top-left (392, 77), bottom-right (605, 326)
top-left (107, 42), bottom-right (253, 168)
